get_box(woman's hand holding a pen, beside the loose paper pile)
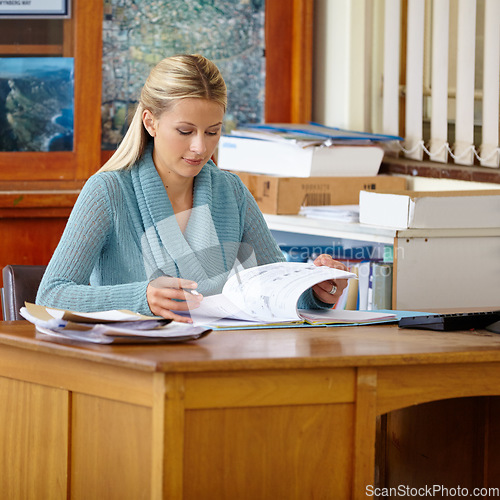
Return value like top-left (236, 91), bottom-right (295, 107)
top-left (146, 276), bottom-right (203, 323)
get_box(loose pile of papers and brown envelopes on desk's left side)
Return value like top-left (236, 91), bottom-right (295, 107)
top-left (20, 302), bottom-right (211, 344)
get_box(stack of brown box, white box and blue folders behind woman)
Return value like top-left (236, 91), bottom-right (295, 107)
top-left (218, 124), bottom-right (406, 215)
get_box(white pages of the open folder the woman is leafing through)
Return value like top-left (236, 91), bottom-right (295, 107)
top-left (176, 262), bottom-right (396, 328)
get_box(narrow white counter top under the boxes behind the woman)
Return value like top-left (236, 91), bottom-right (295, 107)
top-left (264, 214), bottom-right (500, 245)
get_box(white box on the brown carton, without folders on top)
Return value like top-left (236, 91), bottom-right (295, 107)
top-left (217, 136), bottom-right (384, 177)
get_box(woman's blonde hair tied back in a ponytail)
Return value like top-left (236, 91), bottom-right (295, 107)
top-left (99, 54), bottom-right (227, 172)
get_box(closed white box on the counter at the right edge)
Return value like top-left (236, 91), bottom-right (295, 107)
top-left (359, 190), bottom-right (500, 229)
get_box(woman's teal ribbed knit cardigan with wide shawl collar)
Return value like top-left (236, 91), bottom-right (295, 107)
top-left (36, 145), bottom-right (327, 315)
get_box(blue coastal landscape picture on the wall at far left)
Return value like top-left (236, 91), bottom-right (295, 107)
top-left (0, 57), bottom-right (74, 151)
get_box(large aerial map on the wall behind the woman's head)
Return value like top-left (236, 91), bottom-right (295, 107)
top-left (102, 0), bottom-right (265, 149)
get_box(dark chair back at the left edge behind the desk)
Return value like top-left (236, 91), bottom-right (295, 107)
top-left (1, 265), bottom-right (47, 321)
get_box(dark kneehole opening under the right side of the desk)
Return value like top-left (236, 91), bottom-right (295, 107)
top-left (377, 398), bottom-right (500, 498)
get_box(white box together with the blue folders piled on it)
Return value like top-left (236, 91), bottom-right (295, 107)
top-left (218, 124), bottom-right (400, 177)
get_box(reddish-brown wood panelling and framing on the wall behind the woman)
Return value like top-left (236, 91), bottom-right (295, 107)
top-left (0, 0), bottom-right (313, 318)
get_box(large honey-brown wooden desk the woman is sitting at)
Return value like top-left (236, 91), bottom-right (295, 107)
top-left (0, 322), bottom-right (500, 500)
